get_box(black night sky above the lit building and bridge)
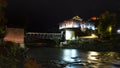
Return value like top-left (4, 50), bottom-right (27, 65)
top-left (6, 0), bottom-right (120, 32)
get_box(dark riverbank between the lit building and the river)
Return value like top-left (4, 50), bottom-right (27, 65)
top-left (55, 39), bottom-right (120, 51)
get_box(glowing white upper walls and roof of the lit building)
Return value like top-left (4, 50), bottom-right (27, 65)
top-left (59, 16), bottom-right (95, 32)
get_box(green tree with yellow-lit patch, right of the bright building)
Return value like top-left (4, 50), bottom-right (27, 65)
top-left (98, 11), bottom-right (116, 36)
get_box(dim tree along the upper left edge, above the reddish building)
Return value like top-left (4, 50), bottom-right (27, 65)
top-left (0, 0), bottom-right (7, 38)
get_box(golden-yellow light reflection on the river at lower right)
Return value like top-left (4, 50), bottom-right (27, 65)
top-left (87, 51), bottom-right (120, 62)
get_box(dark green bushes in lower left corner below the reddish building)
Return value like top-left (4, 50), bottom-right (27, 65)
top-left (0, 42), bottom-right (22, 68)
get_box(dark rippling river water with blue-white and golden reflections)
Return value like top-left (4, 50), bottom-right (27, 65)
top-left (27, 47), bottom-right (120, 68)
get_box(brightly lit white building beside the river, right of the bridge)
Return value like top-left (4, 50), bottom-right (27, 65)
top-left (59, 16), bottom-right (96, 41)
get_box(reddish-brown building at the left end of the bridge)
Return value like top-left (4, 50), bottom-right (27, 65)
top-left (4, 28), bottom-right (24, 43)
